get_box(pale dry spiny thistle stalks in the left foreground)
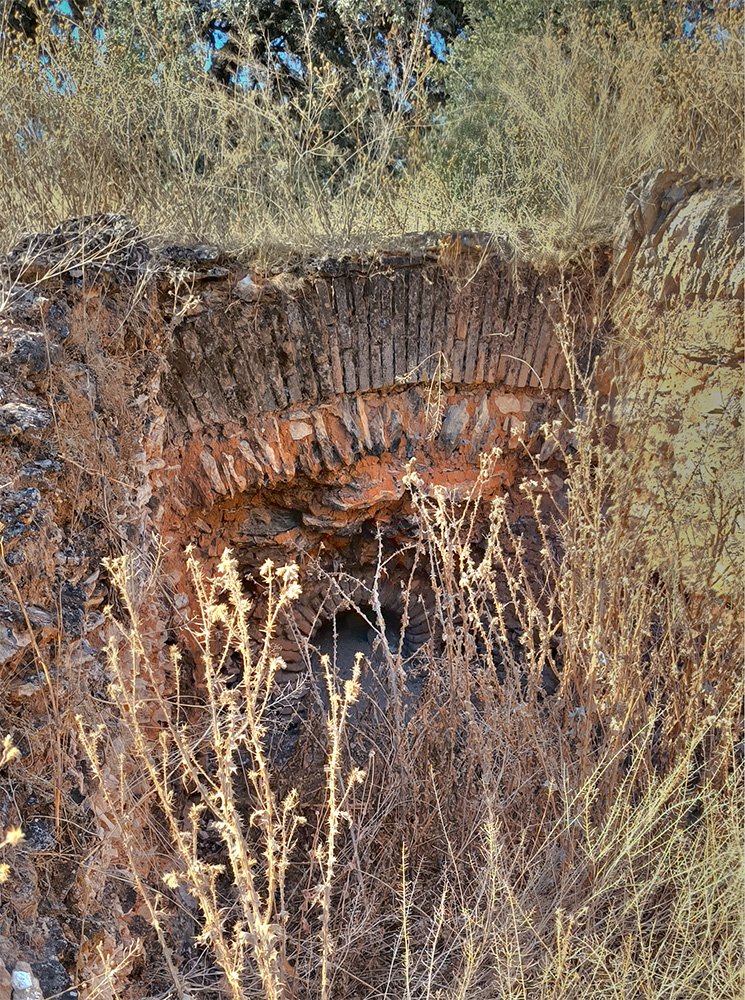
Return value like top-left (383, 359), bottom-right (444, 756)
top-left (79, 550), bottom-right (364, 1000)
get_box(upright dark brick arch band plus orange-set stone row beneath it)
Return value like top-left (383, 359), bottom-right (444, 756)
top-left (155, 248), bottom-right (591, 507)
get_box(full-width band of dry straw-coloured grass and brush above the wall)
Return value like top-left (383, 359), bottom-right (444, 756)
top-left (0, 0), bottom-right (743, 259)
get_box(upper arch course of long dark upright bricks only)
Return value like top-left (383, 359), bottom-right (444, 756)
top-left (161, 246), bottom-right (587, 446)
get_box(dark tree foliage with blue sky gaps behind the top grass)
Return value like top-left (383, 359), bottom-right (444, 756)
top-left (0, 0), bottom-right (465, 91)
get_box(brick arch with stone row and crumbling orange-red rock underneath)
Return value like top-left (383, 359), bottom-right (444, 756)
top-left (149, 248), bottom-right (597, 662)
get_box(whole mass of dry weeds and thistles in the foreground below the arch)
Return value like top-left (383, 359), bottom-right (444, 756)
top-left (78, 310), bottom-right (743, 1000)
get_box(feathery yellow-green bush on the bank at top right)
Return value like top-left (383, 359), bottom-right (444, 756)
top-left (422, 2), bottom-right (743, 253)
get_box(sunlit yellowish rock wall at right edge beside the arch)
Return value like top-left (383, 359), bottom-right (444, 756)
top-left (606, 171), bottom-right (745, 600)
